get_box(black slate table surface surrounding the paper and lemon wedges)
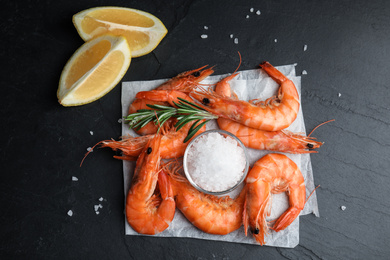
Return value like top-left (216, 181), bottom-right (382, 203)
top-left (0, 0), bottom-right (390, 259)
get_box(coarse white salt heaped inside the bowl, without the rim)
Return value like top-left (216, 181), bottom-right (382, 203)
top-left (187, 133), bottom-right (246, 192)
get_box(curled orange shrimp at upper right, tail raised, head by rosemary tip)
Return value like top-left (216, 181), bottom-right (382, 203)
top-left (190, 62), bottom-right (299, 131)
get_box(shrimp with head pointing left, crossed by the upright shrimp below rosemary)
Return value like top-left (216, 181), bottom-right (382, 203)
top-left (100, 120), bottom-right (206, 160)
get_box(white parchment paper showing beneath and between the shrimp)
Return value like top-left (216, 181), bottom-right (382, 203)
top-left (122, 65), bottom-right (319, 248)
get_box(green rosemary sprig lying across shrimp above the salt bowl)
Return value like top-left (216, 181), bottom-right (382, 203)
top-left (125, 98), bottom-right (218, 142)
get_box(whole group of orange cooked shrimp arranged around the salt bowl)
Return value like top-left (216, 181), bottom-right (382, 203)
top-left (84, 60), bottom-right (330, 245)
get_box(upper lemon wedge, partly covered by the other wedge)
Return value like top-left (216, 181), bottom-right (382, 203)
top-left (73, 6), bottom-right (168, 57)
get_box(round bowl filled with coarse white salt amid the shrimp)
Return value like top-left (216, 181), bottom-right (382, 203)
top-left (183, 129), bottom-right (249, 195)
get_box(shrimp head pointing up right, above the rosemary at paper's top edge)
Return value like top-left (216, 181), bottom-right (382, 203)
top-left (156, 65), bottom-right (214, 92)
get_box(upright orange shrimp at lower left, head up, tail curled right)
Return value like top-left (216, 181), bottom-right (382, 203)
top-left (126, 134), bottom-right (176, 235)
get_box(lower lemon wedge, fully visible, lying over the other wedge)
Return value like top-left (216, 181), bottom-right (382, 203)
top-left (57, 35), bottom-right (131, 106)
